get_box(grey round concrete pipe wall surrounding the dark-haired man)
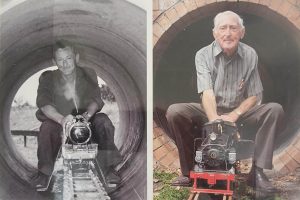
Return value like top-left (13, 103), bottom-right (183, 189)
top-left (0, 0), bottom-right (147, 200)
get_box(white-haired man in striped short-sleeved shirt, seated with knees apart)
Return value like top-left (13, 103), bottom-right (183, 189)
top-left (166, 11), bottom-right (284, 192)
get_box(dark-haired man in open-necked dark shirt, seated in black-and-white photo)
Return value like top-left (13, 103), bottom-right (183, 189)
top-left (35, 40), bottom-right (121, 189)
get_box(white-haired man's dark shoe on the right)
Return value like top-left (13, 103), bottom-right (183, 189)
top-left (247, 166), bottom-right (277, 193)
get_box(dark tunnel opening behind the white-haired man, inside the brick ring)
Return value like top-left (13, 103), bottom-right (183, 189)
top-left (153, 8), bottom-right (300, 151)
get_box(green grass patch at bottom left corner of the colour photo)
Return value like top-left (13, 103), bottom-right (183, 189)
top-left (154, 171), bottom-right (190, 200)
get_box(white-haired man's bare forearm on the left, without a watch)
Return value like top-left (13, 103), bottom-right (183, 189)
top-left (202, 89), bottom-right (221, 121)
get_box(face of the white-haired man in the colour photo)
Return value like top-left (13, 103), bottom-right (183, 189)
top-left (213, 15), bottom-right (245, 56)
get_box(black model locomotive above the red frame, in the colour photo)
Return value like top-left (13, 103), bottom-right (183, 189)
top-left (194, 120), bottom-right (240, 173)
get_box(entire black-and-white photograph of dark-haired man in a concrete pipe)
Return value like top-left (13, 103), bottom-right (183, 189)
top-left (0, 0), bottom-right (147, 200)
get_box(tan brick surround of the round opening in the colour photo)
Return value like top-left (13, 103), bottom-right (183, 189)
top-left (153, 0), bottom-right (300, 174)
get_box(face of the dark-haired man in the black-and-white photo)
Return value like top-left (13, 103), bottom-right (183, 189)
top-left (55, 47), bottom-right (75, 75)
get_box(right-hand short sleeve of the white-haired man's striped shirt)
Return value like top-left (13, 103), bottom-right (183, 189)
top-left (246, 53), bottom-right (263, 101)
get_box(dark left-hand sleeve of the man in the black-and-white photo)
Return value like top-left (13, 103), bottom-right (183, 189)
top-left (36, 71), bottom-right (56, 108)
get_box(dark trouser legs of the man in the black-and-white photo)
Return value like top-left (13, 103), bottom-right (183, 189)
top-left (37, 113), bottom-right (122, 175)
